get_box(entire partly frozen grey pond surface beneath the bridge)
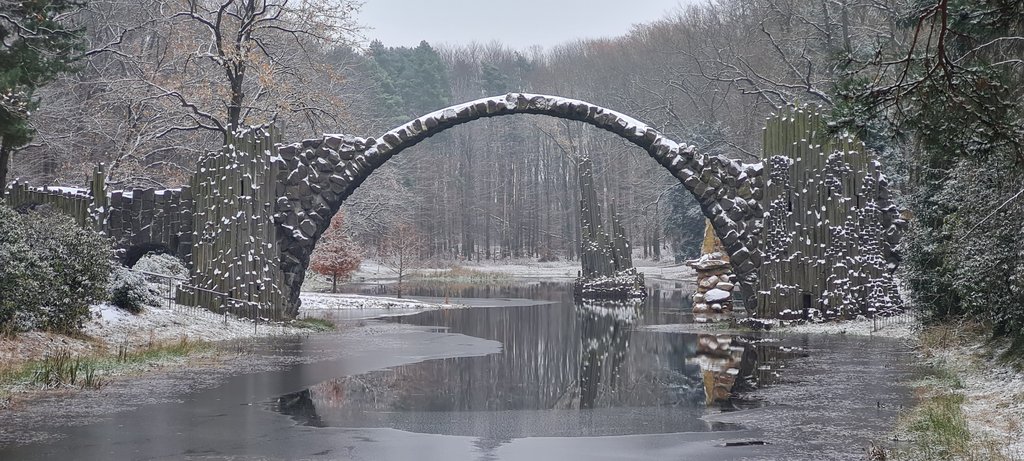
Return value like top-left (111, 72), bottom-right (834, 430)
top-left (0, 283), bottom-right (911, 461)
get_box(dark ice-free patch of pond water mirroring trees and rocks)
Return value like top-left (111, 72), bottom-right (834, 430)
top-left (269, 283), bottom-right (794, 439)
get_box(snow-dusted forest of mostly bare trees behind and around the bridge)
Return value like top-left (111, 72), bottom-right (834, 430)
top-left (0, 0), bottom-right (1024, 344)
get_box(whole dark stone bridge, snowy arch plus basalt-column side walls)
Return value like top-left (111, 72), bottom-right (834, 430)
top-left (4, 93), bottom-right (902, 315)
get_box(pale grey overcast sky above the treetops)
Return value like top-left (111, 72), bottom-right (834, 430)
top-left (359, 0), bottom-right (692, 49)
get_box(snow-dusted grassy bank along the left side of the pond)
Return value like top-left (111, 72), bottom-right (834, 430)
top-left (0, 294), bottom-right (451, 412)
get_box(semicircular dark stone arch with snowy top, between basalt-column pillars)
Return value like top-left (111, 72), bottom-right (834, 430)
top-left (275, 93), bottom-right (763, 312)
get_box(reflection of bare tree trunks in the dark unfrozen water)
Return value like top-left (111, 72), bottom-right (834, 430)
top-left (276, 284), bottom-right (802, 421)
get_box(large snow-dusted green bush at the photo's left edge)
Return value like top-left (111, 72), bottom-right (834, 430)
top-left (0, 206), bottom-right (110, 332)
